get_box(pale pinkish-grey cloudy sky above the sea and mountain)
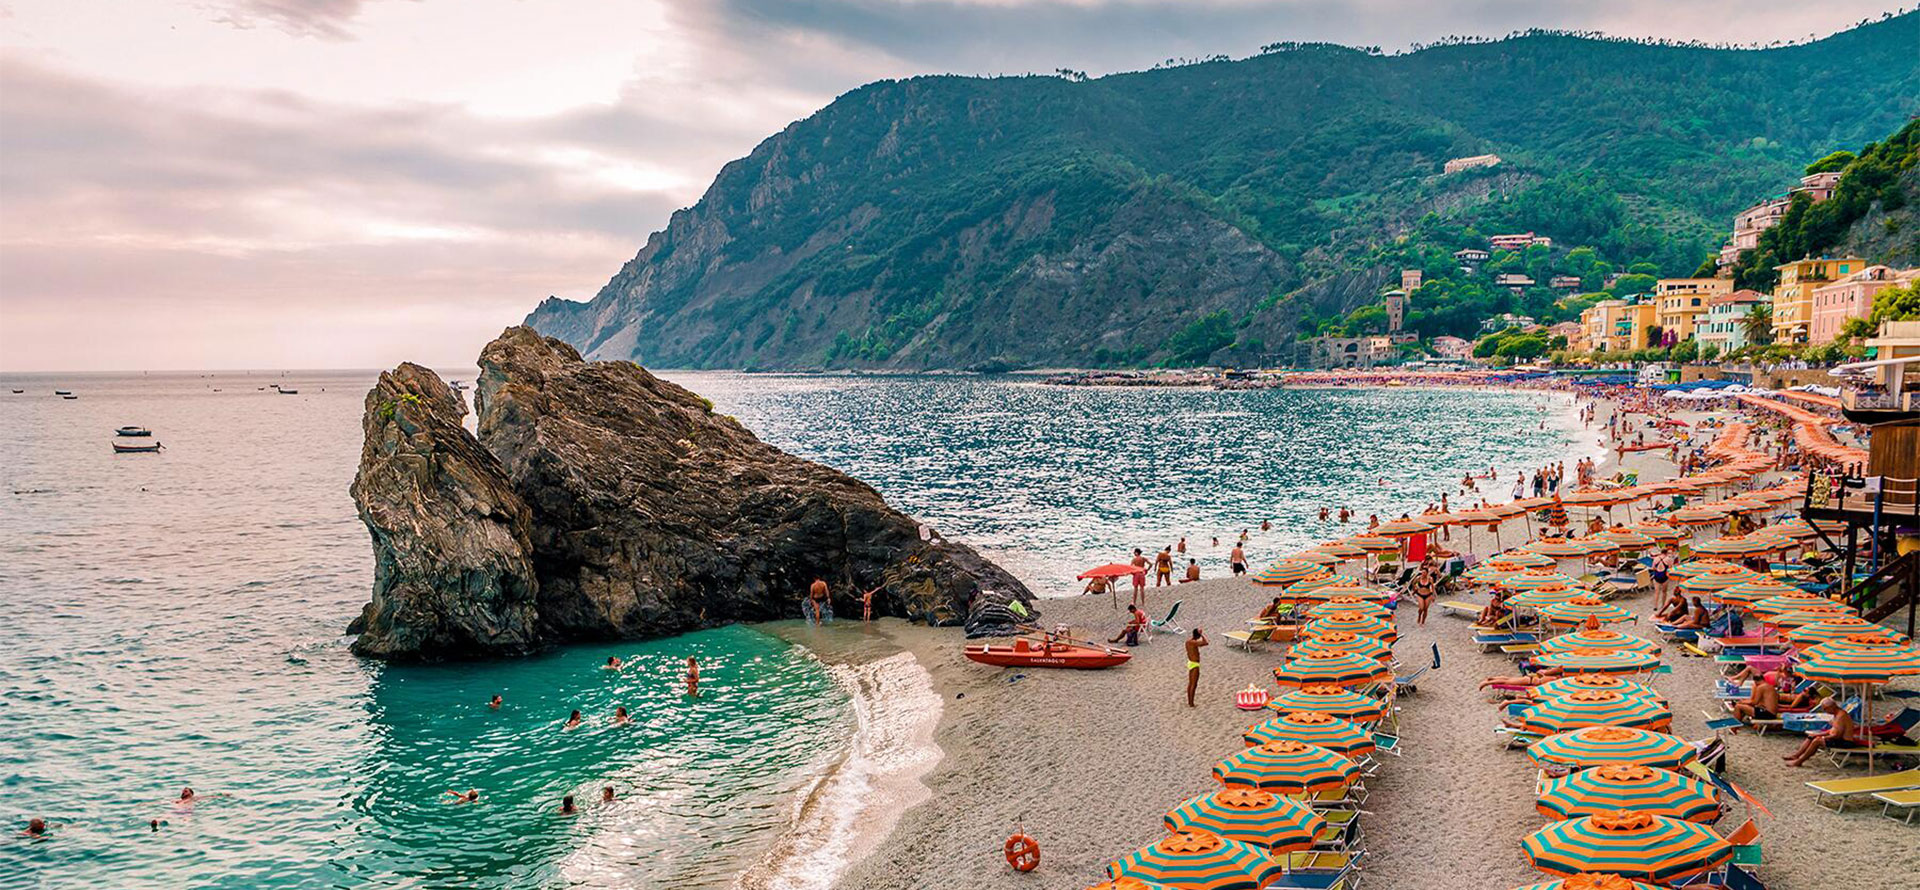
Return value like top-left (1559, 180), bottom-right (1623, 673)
top-left (0, 0), bottom-right (1889, 370)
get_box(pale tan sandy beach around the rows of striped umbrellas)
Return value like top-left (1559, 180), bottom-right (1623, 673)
top-left (772, 398), bottom-right (1920, 890)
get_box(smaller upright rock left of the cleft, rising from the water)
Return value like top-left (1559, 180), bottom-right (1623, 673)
top-left (349, 363), bottom-right (541, 660)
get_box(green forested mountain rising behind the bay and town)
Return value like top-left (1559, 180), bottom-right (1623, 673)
top-left (528, 13), bottom-right (1920, 368)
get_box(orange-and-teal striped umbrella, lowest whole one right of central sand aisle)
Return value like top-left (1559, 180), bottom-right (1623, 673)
top-left (1521, 809), bottom-right (1734, 884)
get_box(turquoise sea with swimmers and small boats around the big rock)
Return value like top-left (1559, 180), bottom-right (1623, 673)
top-left (0, 368), bottom-right (1592, 890)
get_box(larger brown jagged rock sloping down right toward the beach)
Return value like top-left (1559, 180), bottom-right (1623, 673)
top-left (476, 326), bottom-right (1031, 639)
